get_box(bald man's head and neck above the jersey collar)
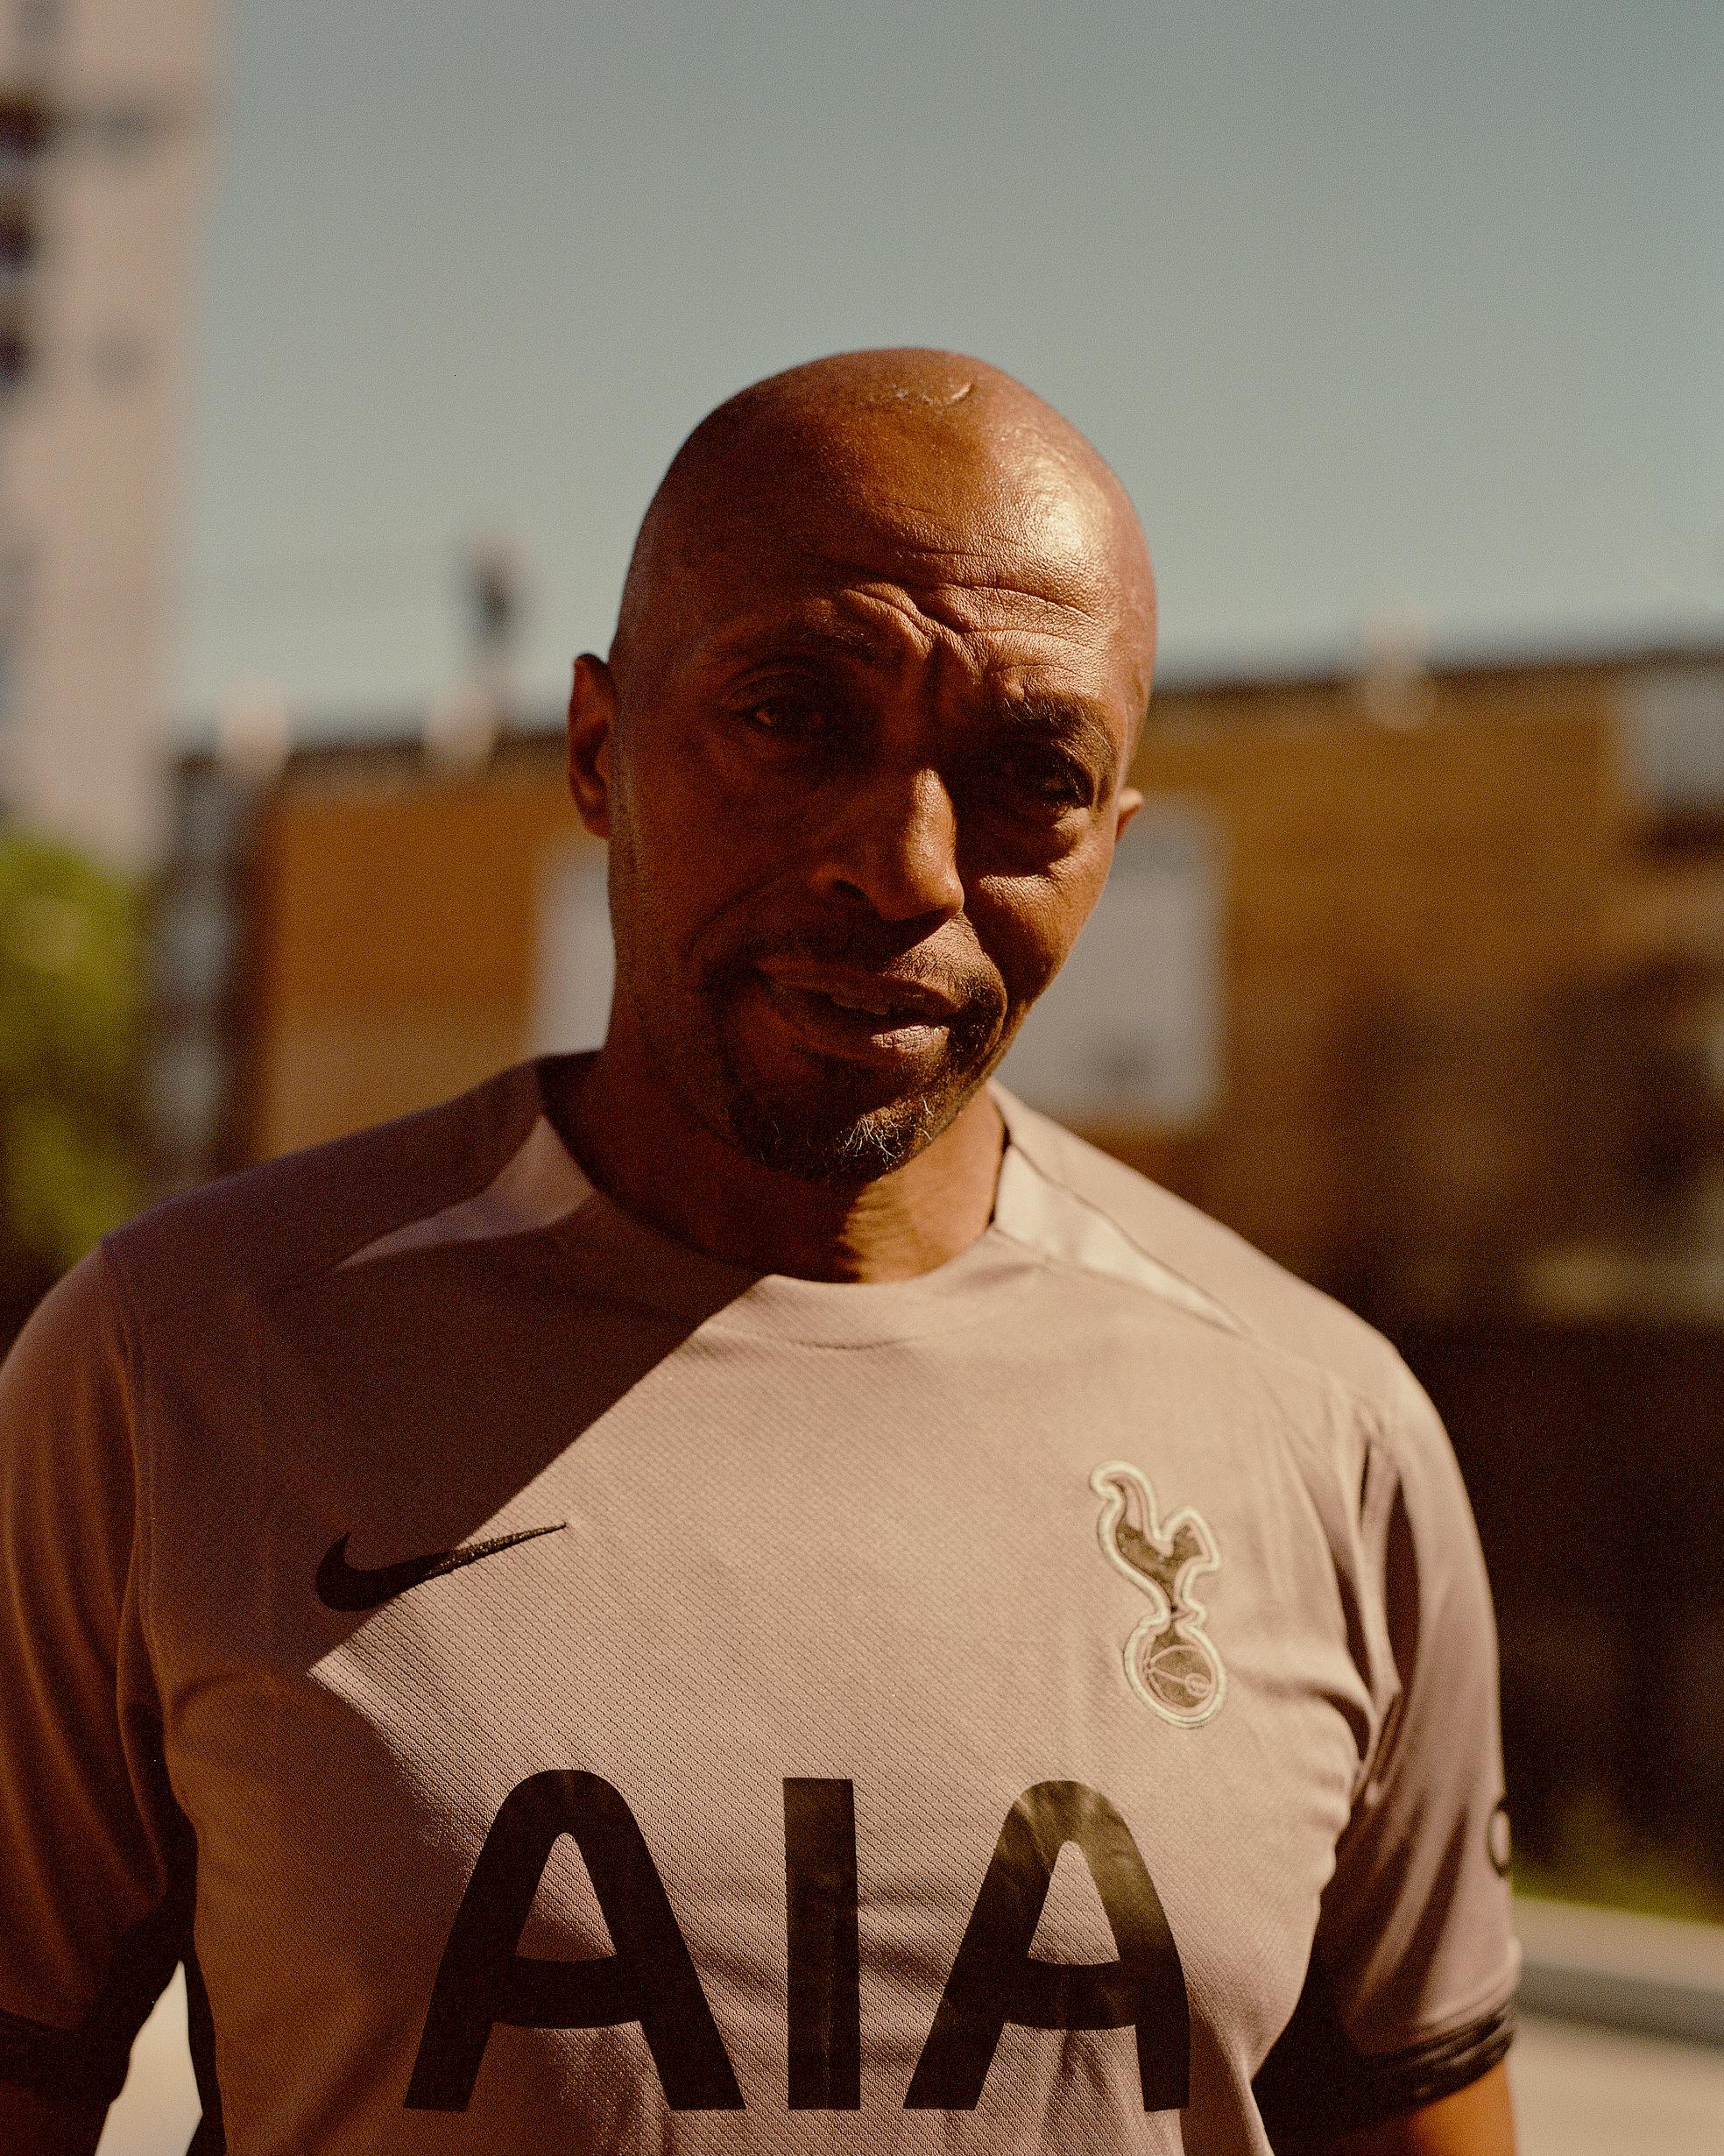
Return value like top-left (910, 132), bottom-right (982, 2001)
top-left (565, 351), bottom-right (1153, 1281)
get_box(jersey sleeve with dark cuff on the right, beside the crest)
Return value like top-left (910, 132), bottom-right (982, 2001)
top-left (1256, 1362), bottom-right (1519, 2138)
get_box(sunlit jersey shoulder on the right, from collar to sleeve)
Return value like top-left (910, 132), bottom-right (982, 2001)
top-left (996, 1089), bottom-right (1411, 1421)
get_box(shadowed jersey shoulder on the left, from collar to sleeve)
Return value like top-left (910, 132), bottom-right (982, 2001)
top-left (106, 1063), bottom-right (543, 1309)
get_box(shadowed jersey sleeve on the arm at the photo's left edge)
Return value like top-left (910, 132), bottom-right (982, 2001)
top-left (0, 1253), bottom-right (189, 2102)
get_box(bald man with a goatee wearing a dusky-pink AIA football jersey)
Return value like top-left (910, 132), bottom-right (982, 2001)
top-left (0, 351), bottom-right (1515, 2156)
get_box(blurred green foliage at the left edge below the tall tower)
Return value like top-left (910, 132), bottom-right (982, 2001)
top-left (0, 830), bottom-right (145, 1294)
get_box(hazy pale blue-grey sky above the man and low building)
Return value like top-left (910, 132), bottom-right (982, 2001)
top-left (174, 0), bottom-right (1724, 716)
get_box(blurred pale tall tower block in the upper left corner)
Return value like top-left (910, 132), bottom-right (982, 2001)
top-left (0, 0), bottom-right (220, 865)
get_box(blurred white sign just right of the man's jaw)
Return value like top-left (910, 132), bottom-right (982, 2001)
top-left (1000, 798), bottom-right (1222, 1127)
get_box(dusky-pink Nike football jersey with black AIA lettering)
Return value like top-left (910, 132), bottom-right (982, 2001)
top-left (0, 1065), bottom-right (1517, 2156)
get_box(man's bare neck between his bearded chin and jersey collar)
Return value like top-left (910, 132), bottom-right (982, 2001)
top-left (552, 1033), bottom-right (1004, 1281)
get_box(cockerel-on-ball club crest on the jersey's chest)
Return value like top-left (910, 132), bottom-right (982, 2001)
top-left (1091, 1460), bottom-right (1226, 1729)
